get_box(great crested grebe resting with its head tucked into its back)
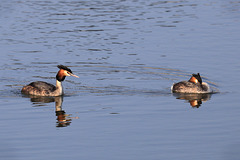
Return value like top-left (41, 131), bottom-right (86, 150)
top-left (171, 73), bottom-right (211, 93)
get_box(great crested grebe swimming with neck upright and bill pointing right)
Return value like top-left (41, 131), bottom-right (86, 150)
top-left (21, 65), bottom-right (79, 96)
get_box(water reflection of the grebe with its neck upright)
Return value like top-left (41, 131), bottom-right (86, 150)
top-left (24, 95), bottom-right (72, 127)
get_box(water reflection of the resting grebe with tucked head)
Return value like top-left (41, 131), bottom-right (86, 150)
top-left (173, 93), bottom-right (212, 108)
